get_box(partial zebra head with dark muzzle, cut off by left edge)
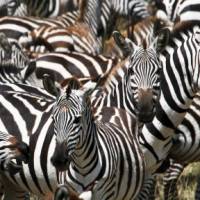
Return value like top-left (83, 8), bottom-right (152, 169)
top-left (0, 132), bottom-right (29, 172)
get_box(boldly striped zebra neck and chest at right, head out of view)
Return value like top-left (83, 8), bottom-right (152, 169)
top-left (136, 19), bottom-right (200, 181)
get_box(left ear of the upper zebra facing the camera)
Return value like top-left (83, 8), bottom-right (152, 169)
top-left (113, 31), bottom-right (136, 57)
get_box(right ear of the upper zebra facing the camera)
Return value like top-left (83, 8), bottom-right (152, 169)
top-left (153, 28), bottom-right (170, 53)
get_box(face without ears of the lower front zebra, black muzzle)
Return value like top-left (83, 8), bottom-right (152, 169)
top-left (51, 92), bottom-right (82, 171)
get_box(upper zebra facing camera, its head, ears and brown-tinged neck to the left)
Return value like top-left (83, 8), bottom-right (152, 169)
top-left (88, 29), bottom-right (169, 122)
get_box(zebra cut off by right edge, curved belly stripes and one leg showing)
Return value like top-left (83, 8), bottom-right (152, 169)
top-left (157, 93), bottom-right (200, 199)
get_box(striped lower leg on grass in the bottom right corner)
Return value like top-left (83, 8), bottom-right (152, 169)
top-left (163, 159), bottom-right (185, 200)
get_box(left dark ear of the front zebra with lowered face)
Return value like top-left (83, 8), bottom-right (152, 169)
top-left (42, 74), bottom-right (60, 97)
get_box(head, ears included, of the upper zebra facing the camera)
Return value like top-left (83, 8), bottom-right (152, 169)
top-left (113, 29), bottom-right (169, 122)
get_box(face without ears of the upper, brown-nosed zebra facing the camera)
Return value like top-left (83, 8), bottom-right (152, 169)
top-left (126, 47), bottom-right (161, 122)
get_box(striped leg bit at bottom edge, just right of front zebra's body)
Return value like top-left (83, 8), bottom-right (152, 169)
top-left (136, 176), bottom-right (156, 200)
